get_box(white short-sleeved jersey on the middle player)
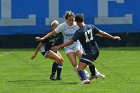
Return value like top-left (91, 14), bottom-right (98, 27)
top-left (55, 22), bottom-right (79, 48)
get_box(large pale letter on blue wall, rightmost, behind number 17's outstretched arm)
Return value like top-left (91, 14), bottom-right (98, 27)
top-left (95, 0), bottom-right (133, 24)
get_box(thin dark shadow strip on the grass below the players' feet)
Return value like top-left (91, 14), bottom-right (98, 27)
top-left (7, 80), bottom-right (79, 85)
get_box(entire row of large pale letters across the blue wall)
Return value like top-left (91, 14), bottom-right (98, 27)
top-left (0, 0), bottom-right (133, 26)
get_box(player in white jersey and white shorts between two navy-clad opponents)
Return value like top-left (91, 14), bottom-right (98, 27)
top-left (36, 11), bottom-right (105, 78)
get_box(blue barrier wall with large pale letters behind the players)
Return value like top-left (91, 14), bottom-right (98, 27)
top-left (0, 0), bottom-right (140, 35)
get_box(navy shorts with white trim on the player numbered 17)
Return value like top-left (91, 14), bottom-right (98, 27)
top-left (80, 52), bottom-right (99, 65)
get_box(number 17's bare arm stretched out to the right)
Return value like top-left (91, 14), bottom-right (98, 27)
top-left (97, 31), bottom-right (121, 41)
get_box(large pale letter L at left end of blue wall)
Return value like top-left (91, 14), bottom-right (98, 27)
top-left (0, 0), bottom-right (36, 26)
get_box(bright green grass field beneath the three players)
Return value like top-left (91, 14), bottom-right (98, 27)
top-left (0, 47), bottom-right (140, 93)
